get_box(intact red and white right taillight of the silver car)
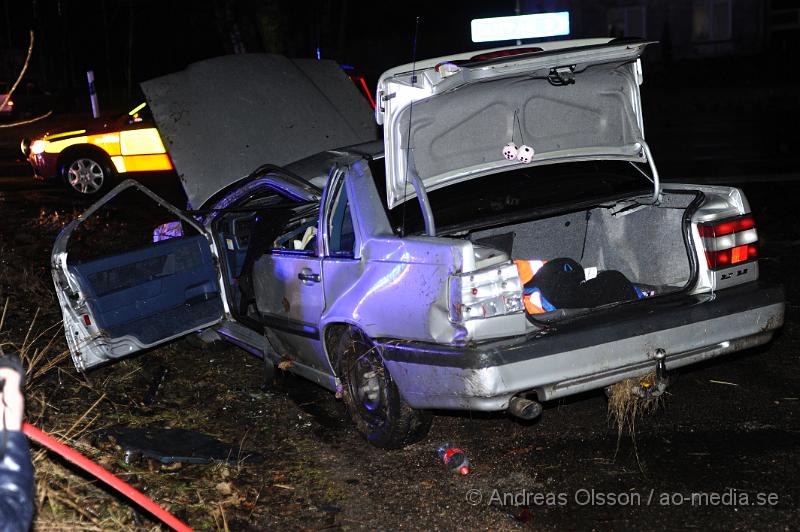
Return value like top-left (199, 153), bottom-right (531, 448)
top-left (697, 215), bottom-right (758, 270)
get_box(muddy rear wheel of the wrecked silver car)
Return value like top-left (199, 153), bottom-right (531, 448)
top-left (335, 328), bottom-right (433, 449)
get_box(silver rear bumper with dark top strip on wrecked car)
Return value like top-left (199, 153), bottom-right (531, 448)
top-left (378, 282), bottom-right (784, 411)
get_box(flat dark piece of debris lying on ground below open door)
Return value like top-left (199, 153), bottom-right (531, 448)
top-left (97, 427), bottom-right (264, 464)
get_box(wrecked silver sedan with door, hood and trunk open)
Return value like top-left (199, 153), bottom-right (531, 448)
top-left (53, 39), bottom-right (784, 448)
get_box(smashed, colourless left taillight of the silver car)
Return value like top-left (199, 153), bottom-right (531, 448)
top-left (449, 261), bottom-right (524, 323)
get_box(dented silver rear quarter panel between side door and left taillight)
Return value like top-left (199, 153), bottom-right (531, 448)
top-left (310, 160), bottom-right (526, 350)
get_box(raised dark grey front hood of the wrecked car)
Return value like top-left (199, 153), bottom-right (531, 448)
top-left (142, 54), bottom-right (377, 208)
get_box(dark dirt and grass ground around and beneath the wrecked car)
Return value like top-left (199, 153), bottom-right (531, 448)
top-left (0, 164), bottom-right (800, 530)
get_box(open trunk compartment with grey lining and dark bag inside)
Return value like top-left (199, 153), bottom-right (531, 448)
top-left (450, 191), bottom-right (702, 322)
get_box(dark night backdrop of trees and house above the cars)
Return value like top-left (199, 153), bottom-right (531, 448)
top-left (0, 0), bottom-right (800, 108)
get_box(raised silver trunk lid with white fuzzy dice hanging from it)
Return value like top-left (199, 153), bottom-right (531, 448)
top-left (376, 39), bottom-right (657, 208)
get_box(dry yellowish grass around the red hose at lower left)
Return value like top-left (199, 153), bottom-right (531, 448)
top-left (0, 300), bottom-right (263, 531)
